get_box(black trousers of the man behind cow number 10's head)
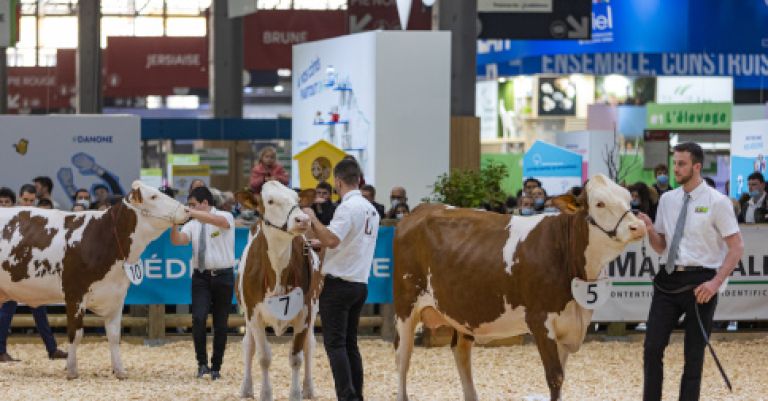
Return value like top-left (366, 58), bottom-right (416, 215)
top-left (192, 269), bottom-right (235, 371)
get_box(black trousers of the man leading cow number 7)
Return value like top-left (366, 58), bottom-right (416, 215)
top-left (320, 275), bottom-right (368, 401)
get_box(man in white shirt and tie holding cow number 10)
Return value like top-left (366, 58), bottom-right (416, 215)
top-left (171, 187), bottom-right (235, 380)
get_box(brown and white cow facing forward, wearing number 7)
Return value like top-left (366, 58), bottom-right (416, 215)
top-left (237, 181), bottom-right (322, 401)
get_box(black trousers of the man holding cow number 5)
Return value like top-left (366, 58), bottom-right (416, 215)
top-left (643, 269), bottom-right (717, 401)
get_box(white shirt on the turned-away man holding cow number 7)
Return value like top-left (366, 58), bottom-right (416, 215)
top-left (323, 190), bottom-right (379, 283)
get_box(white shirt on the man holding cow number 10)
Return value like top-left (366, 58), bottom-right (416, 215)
top-left (181, 207), bottom-right (235, 270)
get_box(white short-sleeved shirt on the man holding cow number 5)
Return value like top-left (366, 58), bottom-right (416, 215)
top-left (654, 181), bottom-right (739, 269)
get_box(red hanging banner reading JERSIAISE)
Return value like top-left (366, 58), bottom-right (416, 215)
top-left (104, 36), bottom-right (208, 97)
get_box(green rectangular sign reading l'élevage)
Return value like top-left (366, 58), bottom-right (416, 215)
top-left (646, 103), bottom-right (733, 130)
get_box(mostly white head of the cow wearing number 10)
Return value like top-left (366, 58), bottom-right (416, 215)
top-left (126, 180), bottom-right (189, 229)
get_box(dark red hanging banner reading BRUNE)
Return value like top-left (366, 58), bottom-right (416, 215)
top-left (243, 10), bottom-right (347, 70)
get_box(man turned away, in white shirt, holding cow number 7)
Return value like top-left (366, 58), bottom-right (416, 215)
top-left (304, 159), bottom-right (379, 401)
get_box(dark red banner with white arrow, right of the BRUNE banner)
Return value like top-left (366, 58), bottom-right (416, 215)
top-left (347, 0), bottom-right (432, 33)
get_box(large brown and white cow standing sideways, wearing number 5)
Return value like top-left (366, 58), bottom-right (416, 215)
top-left (393, 175), bottom-right (645, 401)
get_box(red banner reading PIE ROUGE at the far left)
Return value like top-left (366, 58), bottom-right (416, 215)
top-left (8, 67), bottom-right (70, 113)
